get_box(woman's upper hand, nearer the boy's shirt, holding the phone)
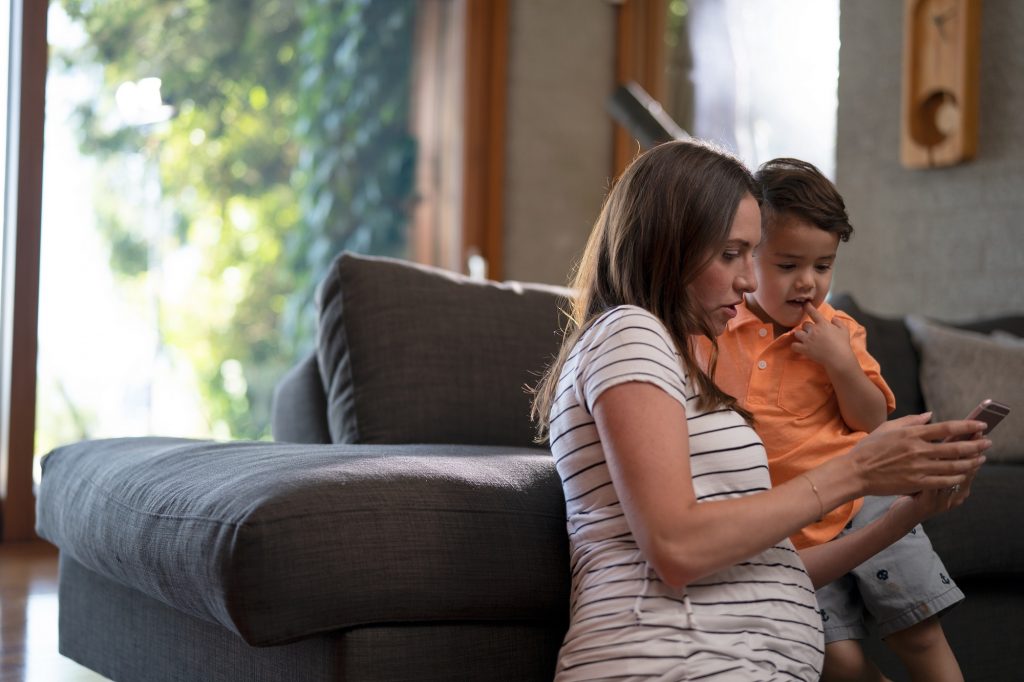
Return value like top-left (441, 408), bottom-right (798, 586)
top-left (845, 414), bottom-right (992, 493)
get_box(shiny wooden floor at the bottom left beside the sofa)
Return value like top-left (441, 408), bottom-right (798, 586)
top-left (0, 542), bottom-right (106, 682)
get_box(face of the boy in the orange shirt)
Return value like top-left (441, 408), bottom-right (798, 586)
top-left (751, 216), bottom-right (839, 329)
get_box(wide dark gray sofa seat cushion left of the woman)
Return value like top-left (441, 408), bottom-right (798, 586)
top-left (37, 437), bottom-right (569, 645)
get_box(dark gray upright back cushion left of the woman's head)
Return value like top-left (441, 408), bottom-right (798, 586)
top-left (316, 253), bottom-right (568, 446)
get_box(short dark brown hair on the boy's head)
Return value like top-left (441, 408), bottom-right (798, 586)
top-left (754, 158), bottom-right (853, 242)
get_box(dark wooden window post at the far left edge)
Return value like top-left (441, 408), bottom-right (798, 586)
top-left (0, 1), bottom-right (47, 542)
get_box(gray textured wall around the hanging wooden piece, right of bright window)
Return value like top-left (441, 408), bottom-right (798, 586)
top-left (835, 0), bottom-right (1024, 319)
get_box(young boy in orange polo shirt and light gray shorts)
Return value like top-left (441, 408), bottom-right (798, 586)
top-left (700, 159), bottom-right (964, 682)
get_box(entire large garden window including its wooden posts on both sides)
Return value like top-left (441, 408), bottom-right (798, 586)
top-left (0, 0), bottom-right (507, 541)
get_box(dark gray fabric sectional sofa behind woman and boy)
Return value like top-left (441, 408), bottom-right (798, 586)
top-left (38, 254), bottom-right (1024, 681)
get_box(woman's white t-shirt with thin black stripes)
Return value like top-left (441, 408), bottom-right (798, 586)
top-left (551, 306), bottom-right (824, 682)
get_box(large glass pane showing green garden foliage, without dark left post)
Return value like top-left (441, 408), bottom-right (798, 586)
top-left (36, 0), bottom-right (462, 473)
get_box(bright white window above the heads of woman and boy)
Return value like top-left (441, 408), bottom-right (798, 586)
top-left (665, 0), bottom-right (839, 177)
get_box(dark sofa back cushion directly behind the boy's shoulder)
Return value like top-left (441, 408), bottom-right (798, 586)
top-left (828, 294), bottom-right (926, 419)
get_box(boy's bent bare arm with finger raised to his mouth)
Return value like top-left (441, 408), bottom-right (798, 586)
top-left (793, 303), bottom-right (888, 432)
